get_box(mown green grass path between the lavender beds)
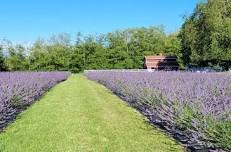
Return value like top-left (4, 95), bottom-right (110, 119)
top-left (0, 75), bottom-right (183, 152)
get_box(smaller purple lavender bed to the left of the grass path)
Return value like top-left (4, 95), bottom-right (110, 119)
top-left (0, 72), bottom-right (69, 129)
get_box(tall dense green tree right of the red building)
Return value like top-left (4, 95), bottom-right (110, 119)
top-left (179, 0), bottom-right (231, 69)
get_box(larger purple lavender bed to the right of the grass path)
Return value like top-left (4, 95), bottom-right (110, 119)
top-left (86, 71), bottom-right (231, 150)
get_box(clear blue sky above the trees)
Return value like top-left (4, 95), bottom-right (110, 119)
top-left (0, 0), bottom-right (200, 43)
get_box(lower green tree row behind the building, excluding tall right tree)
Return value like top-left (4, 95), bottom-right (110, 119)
top-left (0, 27), bottom-right (182, 72)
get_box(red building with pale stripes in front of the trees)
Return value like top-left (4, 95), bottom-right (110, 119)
top-left (144, 55), bottom-right (179, 70)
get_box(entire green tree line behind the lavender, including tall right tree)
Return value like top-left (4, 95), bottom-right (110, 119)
top-left (0, 0), bottom-right (231, 72)
